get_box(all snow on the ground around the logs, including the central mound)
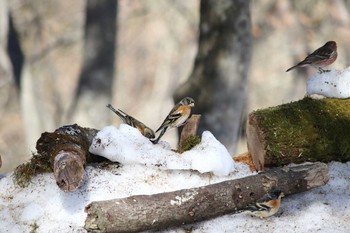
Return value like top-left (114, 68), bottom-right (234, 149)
top-left (0, 126), bottom-right (350, 233)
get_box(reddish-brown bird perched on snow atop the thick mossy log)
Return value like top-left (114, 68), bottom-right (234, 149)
top-left (286, 41), bottom-right (338, 73)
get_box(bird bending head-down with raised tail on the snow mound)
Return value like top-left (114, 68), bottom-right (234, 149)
top-left (106, 104), bottom-right (155, 139)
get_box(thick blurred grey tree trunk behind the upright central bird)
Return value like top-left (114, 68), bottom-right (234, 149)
top-left (174, 0), bottom-right (252, 153)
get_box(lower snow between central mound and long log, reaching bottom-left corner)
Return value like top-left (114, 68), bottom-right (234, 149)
top-left (0, 148), bottom-right (254, 233)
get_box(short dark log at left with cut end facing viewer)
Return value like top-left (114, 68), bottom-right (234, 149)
top-left (36, 124), bottom-right (98, 192)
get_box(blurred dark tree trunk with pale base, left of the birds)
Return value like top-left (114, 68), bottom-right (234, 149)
top-left (68, 0), bottom-right (118, 128)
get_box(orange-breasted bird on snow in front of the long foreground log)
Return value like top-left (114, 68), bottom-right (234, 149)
top-left (239, 189), bottom-right (284, 218)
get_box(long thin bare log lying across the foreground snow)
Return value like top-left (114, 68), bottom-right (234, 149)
top-left (85, 163), bottom-right (328, 232)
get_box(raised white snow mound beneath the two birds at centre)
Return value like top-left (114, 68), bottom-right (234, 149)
top-left (90, 124), bottom-right (235, 176)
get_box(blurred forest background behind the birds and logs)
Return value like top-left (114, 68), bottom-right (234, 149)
top-left (0, 0), bottom-right (350, 173)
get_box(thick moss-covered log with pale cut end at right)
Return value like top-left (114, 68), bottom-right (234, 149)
top-left (247, 98), bottom-right (350, 170)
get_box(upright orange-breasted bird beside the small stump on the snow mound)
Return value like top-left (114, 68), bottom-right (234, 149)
top-left (151, 97), bottom-right (194, 144)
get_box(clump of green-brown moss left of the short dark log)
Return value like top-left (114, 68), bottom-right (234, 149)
top-left (13, 154), bottom-right (53, 188)
